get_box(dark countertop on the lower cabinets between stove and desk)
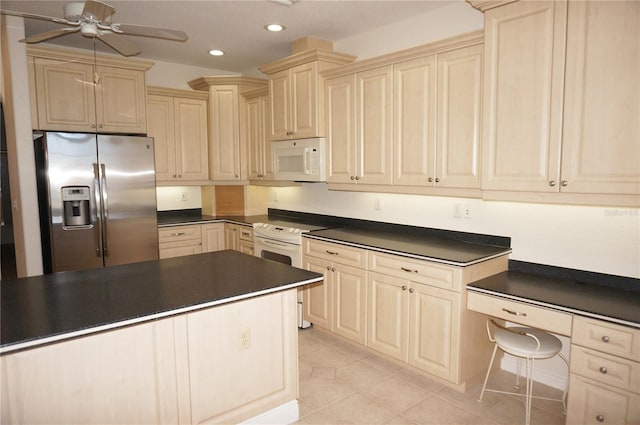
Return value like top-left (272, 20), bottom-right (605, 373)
top-left (304, 227), bottom-right (511, 266)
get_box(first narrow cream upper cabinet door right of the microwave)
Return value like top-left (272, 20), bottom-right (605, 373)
top-left (325, 74), bottom-right (357, 183)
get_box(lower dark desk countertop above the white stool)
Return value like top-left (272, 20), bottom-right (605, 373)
top-left (467, 270), bottom-right (640, 328)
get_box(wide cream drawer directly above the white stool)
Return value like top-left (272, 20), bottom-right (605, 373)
top-left (467, 292), bottom-right (571, 336)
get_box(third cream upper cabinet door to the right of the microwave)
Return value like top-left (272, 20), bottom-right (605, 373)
top-left (393, 55), bottom-right (436, 186)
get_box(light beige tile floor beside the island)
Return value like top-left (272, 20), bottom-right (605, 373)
top-left (297, 328), bottom-right (565, 425)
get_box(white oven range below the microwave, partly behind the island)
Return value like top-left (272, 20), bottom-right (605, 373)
top-left (253, 220), bottom-right (326, 328)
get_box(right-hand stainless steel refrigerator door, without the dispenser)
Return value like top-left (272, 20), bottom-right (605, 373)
top-left (98, 135), bottom-right (158, 266)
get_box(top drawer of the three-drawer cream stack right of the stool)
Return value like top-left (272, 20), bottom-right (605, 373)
top-left (571, 316), bottom-right (640, 360)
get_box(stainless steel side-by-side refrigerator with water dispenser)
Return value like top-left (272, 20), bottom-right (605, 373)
top-left (34, 132), bottom-right (158, 273)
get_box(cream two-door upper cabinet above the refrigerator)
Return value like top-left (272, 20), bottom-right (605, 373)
top-left (28, 47), bottom-right (150, 134)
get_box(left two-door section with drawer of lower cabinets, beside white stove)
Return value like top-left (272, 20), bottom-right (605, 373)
top-left (303, 240), bottom-right (367, 344)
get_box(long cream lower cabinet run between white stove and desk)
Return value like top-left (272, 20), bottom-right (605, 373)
top-left (303, 238), bottom-right (508, 387)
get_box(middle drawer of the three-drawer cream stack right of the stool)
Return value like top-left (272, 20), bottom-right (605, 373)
top-left (571, 344), bottom-right (640, 393)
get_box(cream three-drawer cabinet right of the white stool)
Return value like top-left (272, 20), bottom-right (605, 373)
top-left (567, 316), bottom-right (640, 424)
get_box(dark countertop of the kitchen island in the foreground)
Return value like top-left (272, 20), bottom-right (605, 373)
top-left (0, 250), bottom-right (322, 353)
